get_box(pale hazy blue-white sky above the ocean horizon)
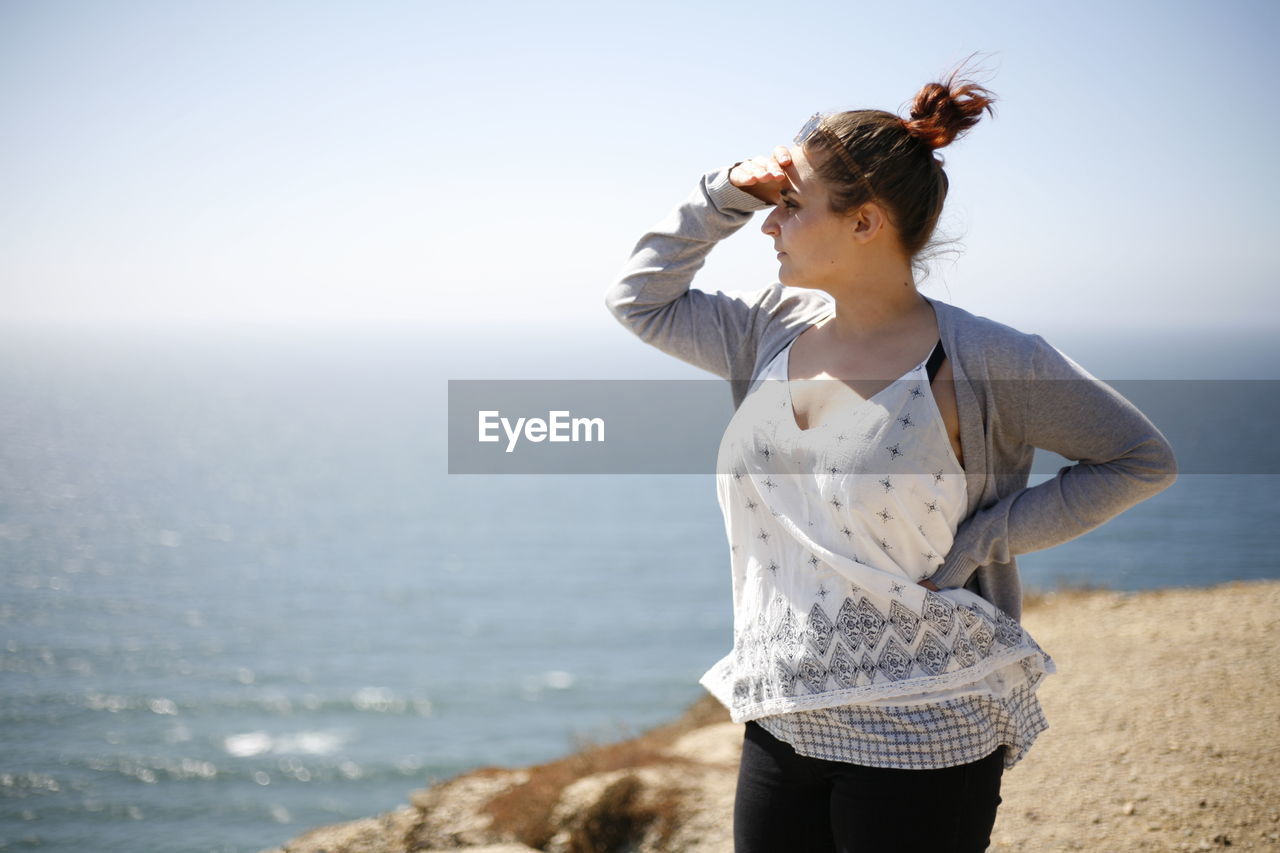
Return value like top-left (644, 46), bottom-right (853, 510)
top-left (0, 0), bottom-right (1280, 328)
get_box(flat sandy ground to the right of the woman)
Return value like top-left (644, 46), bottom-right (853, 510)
top-left (992, 581), bottom-right (1280, 850)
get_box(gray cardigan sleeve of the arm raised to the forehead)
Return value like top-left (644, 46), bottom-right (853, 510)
top-left (604, 168), bottom-right (780, 379)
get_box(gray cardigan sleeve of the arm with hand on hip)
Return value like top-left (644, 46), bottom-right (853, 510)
top-left (932, 336), bottom-right (1178, 587)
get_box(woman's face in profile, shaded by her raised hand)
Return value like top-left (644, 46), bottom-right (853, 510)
top-left (760, 146), bottom-right (880, 289)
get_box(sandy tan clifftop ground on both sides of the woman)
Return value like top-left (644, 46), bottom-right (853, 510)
top-left (264, 581), bottom-right (1280, 853)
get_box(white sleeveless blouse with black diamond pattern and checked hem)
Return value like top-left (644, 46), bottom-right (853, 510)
top-left (703, 341), bottom-right (1053, 770)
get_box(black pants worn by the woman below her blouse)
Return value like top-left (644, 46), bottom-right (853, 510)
top-left (733, 722), bottom-right (1005, 853)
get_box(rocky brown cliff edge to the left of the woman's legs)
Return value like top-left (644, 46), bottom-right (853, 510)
top-left (265, 697), bottom-right (742, 853)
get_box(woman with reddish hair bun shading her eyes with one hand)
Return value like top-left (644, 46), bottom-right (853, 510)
top-left (607, 63), bottom-right (1175, 853)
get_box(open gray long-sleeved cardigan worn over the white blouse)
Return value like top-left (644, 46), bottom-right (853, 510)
top-left (605, 168), bottom-right (1176, 619)
